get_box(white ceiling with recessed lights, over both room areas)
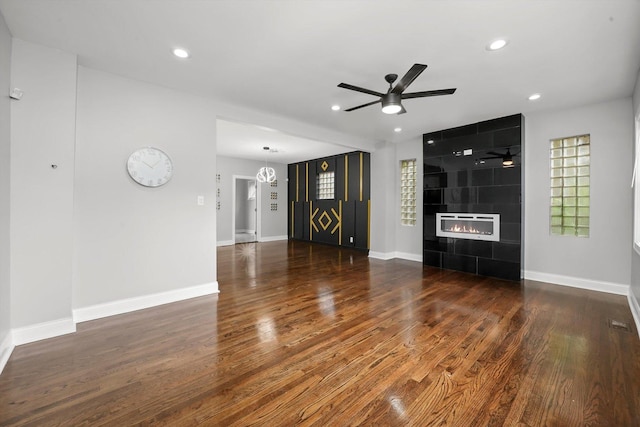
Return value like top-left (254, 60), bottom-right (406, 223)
top-left (0, 0), bottom-right (640, 163)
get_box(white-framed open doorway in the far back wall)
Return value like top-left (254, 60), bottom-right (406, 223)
top-left (231, 175), bottom-right (260, 243)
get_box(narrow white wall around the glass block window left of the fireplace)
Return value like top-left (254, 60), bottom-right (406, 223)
top-left (393, 137), bottom-right (424, 262)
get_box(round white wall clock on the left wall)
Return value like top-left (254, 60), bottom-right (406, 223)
top-left (127, 147), bottom-right (173, 187)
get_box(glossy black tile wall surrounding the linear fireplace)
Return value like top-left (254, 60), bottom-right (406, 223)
top-left (423, 114), bottom-right (524, 280)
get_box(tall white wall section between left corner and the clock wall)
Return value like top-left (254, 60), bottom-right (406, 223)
top-left (9, 39), bottom-right (77, 329)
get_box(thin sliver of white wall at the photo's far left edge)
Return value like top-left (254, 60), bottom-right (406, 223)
top-left (0, 10), bottom-right (13, 372)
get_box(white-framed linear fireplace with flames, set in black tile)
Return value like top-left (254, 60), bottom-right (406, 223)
top-left (436, 213), bottom-right (500, 242)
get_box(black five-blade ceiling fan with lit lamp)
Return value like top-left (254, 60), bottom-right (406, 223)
top-left (338, 64), bottom-right (456, 114)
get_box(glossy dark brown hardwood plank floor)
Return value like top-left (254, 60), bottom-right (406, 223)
top-left (0, 242), bottom-right (640, 426)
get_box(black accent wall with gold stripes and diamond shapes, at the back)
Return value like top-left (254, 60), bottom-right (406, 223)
top-left (287, 151), bottom-right (371, 250)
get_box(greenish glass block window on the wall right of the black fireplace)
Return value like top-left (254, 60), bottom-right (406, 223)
top-left (550, 135), bottom-right (591, 237)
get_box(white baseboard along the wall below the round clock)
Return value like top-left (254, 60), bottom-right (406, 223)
top-left (73, 282), bottom-right (220, 323)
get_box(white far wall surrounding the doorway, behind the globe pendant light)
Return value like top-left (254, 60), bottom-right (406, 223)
top-left (216, 156), bottom-right (287, 244)
